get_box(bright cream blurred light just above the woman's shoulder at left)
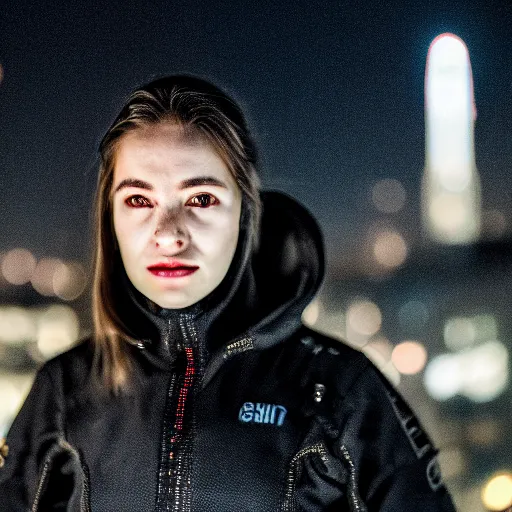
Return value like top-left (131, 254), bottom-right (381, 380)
top-left (37, 305), bottom-right (80, 359)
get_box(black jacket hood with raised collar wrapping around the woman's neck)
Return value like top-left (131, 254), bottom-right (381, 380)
top-left (120, 191), bottom-right (324, 367)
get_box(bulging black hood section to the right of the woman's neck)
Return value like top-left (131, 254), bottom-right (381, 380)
top-left (243, 192), bottom-right (325, 348)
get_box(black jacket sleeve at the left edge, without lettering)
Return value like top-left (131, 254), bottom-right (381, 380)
top-left (0, 367), bottom-right (60, 512)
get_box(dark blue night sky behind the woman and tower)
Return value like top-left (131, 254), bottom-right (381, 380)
top-left (0, 0), bottom-right (512, 270)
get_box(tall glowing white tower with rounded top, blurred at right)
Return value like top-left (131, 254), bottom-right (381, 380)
top-left (422, 33), bottom-right (481, 244)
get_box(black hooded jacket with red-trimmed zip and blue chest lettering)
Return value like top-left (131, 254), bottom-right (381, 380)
top-left (0, 192), bottom-right (454, 512)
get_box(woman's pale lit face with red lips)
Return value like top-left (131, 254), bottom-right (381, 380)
top-left (112, 123), bottom-right (242, 309)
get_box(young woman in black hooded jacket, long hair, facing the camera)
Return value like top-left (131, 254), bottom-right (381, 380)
top-left (0, 76), bottom-right (453, 512)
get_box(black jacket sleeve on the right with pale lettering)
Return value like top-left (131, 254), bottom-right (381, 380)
top-left (341, 365), bottom-right (455, 512)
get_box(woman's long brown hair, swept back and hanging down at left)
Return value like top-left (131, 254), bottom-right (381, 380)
top-left (92, 75), bottom-right (261, 392)
